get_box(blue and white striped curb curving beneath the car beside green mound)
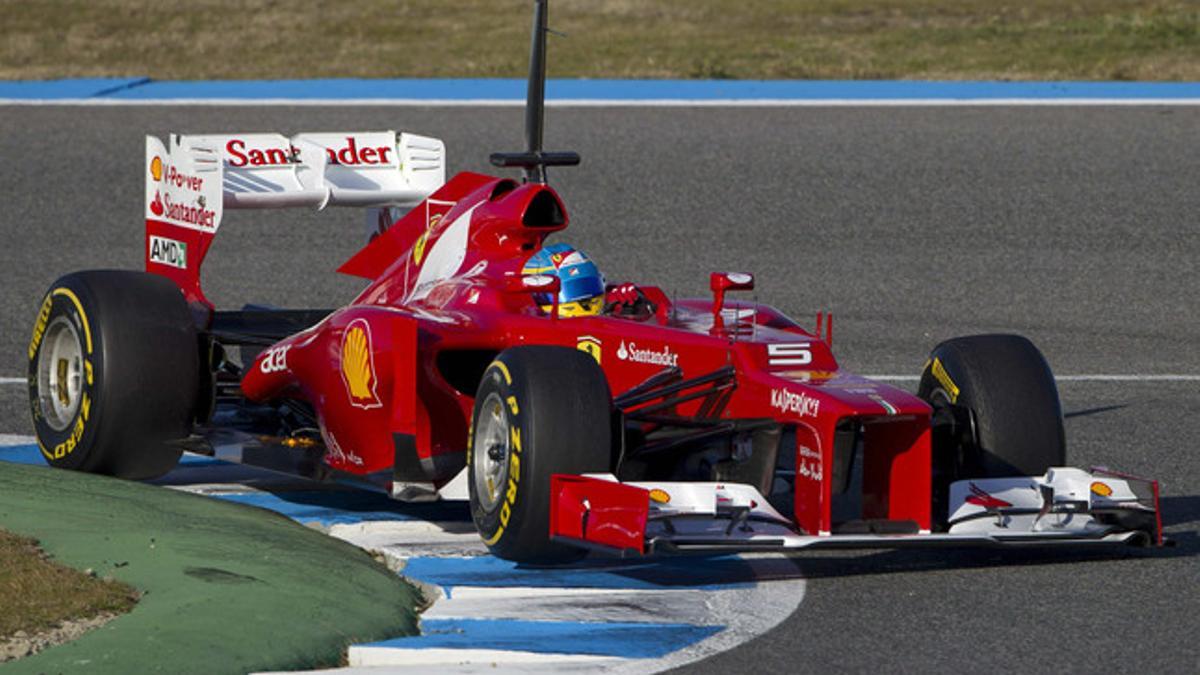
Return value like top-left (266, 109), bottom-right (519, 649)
top-left (0, 435), bottom-right (804, 673)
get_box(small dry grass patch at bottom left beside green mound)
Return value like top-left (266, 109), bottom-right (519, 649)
top-left (0, 530), bottom-right (137, 638)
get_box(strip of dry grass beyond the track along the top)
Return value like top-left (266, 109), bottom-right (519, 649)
top-left (0, 0), bottom-right (1200, 80)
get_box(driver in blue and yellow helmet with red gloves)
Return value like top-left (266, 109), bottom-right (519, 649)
top-left (521, 244), bottom-right (654, 317)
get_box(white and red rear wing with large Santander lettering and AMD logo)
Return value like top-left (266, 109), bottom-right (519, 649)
top-left (145, 131), bottom-right (445, 309)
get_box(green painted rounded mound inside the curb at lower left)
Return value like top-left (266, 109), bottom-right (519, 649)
top-left (0, 462), bottom-right (419, 674)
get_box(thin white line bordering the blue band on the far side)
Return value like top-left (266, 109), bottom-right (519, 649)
top-left (0, 98), bottom-right (1200, 108)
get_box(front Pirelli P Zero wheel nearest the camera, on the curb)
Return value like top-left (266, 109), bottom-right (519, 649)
top-left (467, 346), bottom-right (612, 565)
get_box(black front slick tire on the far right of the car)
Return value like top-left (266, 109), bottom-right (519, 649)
top-left (918, 335), bottom-right (1067, 484)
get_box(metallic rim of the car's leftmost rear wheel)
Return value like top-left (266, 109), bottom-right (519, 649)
top-left (37, 316), bottom-right (83, 431)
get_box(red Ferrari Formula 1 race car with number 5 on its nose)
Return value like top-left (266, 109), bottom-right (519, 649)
top-left (28, 0), bottom-right (1163, 562)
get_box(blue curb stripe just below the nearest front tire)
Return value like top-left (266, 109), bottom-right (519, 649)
top-left (404, 556), bottom-right (756, 588)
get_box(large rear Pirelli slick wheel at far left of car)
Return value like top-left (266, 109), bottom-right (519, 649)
top-left (28, 270), bottom-right (199, 479)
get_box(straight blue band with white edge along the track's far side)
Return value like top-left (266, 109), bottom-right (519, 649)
top-left (0, 77), bottom-right (1200, 107)
